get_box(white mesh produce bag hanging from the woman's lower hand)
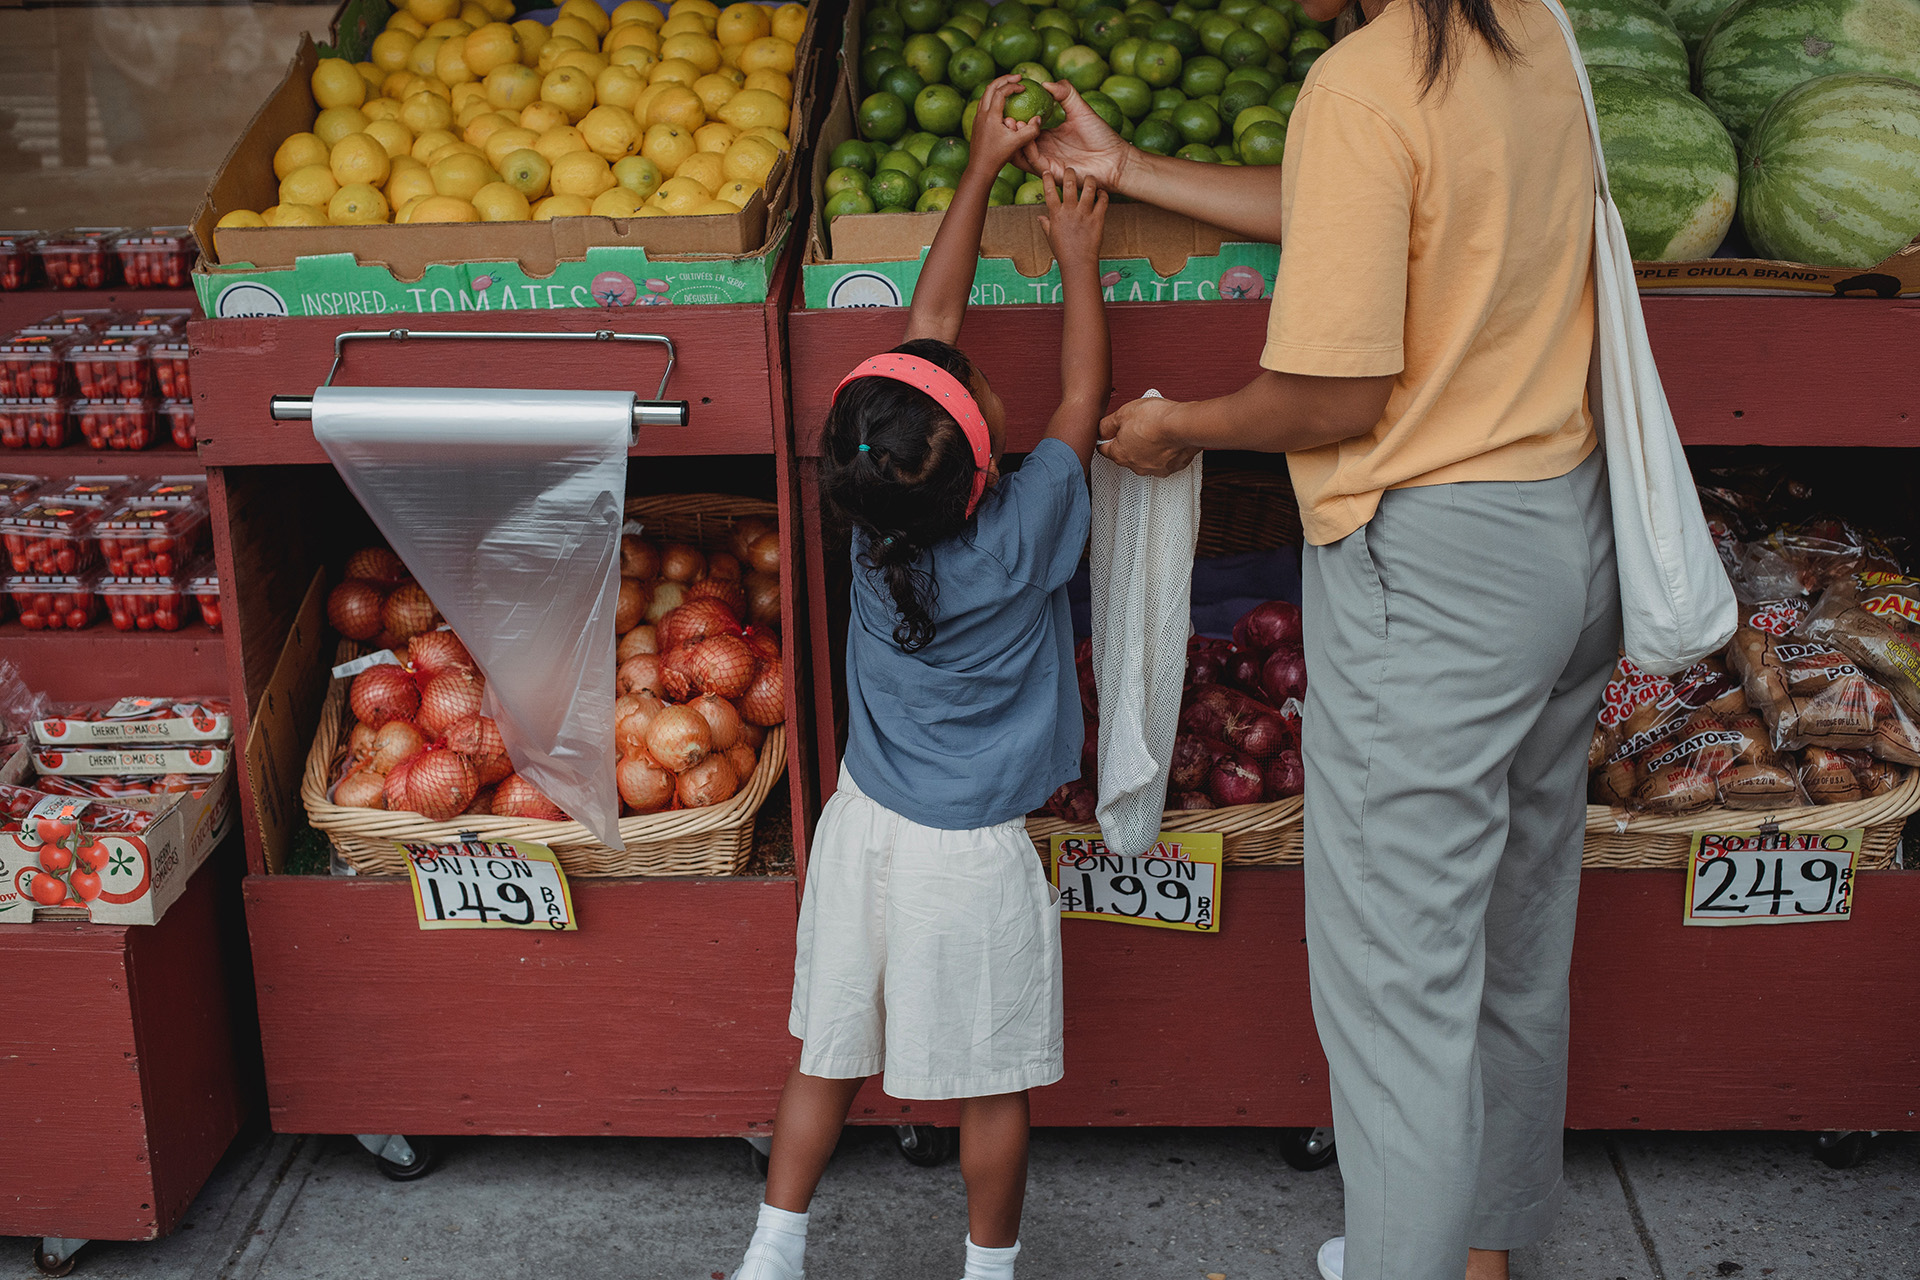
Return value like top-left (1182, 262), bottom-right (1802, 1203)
top-left (1092, 402), bottom-right (1200, 856)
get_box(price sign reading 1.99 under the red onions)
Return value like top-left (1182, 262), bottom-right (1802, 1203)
top-left (1046, 831), bottom-right (1221, 933)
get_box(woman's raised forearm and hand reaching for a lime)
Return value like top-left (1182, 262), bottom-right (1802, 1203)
top-left (1016, 83), bottom-right (1281, 244)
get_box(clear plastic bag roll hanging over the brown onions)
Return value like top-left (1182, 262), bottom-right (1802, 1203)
top-left (313, 386), bottom-right (634, 848)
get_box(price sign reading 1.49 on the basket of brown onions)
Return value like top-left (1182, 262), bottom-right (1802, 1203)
top-left (399, 839), bottom-right (578, 929)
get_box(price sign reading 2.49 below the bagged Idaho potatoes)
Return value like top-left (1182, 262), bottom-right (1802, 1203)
top-left (1686, 827), bottom-right (1866, 925)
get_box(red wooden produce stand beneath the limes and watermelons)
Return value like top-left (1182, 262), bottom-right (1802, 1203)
top-left (789, 297), bottom-right (1920, 1130)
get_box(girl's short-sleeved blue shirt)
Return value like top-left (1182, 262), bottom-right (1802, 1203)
top-left (847, 439), bottom-right (1091, 831)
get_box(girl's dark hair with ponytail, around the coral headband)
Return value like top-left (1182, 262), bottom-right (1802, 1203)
top-left (820, 338), bottom-right (973, 652)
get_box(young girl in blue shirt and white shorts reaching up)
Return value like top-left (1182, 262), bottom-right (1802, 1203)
top-left (733, 77), bottom-right (1112, 1280)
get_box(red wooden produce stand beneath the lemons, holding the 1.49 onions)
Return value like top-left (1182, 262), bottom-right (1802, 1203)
top-left (192, 237), bottom-right (818, 1176)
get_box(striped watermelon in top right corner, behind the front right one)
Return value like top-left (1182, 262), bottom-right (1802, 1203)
top-left (1699, 0), bottom-right (1920, 142)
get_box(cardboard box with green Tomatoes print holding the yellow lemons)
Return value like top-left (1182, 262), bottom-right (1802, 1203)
top-left (194, 0), bottom-right (818, 319)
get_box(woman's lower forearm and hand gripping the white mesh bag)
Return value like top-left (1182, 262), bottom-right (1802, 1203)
top-left (1100, 368), bottom-right (1394, 476)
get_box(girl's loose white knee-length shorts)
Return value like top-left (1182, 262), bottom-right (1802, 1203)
top-left (787, 768), bottom-right (1064, 1100)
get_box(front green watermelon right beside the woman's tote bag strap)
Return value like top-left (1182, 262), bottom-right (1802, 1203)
top-left (1590, 67), bottom-right (1740, 263)
